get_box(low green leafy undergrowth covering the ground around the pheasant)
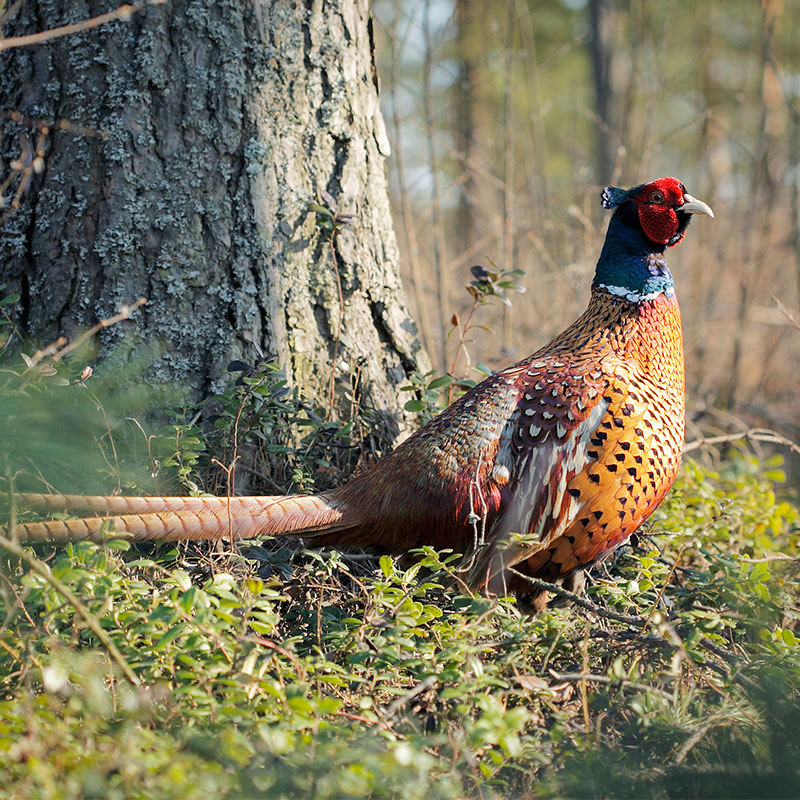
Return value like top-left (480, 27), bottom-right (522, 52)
top-left (0, 290), bottom-right (800, 799)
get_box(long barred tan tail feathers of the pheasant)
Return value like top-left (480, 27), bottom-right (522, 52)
top-left (4, 495), bottom-right (359, 543)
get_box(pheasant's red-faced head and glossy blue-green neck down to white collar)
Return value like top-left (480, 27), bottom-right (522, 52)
top-left (592, 178), bottom-right (714, 301)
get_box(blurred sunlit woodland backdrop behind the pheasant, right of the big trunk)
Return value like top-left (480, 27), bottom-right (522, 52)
top-left (375, 0), bottom-right (800, 476)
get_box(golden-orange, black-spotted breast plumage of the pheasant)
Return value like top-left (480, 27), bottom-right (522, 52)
top-left (490, 290), bottom-right (684, 590)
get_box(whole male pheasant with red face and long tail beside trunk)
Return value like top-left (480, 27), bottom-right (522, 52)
top-left (7, 178), bottom-right (714, 608)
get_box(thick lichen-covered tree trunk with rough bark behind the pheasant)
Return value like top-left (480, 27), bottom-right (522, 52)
top-left (0, 0), bottom-right (427, 438)
